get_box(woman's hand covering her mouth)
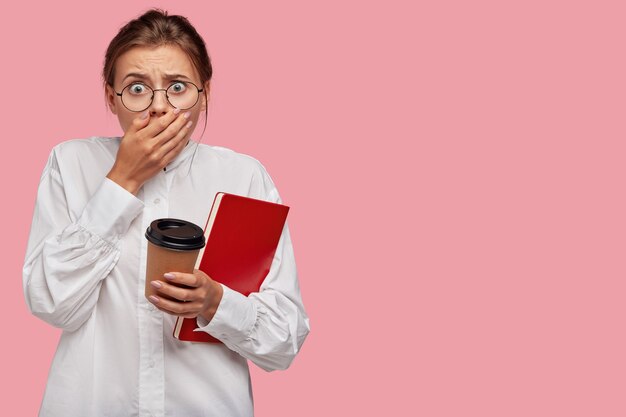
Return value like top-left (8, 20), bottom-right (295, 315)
top-left (107, 108), bottom-right (191, 195)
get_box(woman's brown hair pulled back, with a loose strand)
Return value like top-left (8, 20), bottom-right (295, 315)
top-left (102, 8), bottom-right (213, 136)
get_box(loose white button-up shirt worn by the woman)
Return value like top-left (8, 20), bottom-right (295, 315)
top-left (23, 137), bottom-right (309, 417)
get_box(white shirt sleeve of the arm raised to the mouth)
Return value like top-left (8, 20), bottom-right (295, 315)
top-left (23, 150), bottom-right (144, 331)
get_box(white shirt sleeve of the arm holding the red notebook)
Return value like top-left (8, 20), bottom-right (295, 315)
top-left (195, 169), bottom-right (310, 371)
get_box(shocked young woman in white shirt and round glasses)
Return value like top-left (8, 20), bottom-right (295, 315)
top-left (23, 9), bottom-right (309, 417)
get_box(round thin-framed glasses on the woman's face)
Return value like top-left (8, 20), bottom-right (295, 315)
top-left (115, 81), bottom-right (203, 112)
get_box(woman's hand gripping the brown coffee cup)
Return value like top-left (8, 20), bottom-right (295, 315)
top-left (149, 269), bottom-right (224, 321)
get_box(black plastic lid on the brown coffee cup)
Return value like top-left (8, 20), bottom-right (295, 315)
top-left (146, 218), bottom-right (205, 250)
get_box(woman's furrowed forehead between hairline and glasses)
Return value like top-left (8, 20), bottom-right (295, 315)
top-left (115, 45), bottom-right (198, 83)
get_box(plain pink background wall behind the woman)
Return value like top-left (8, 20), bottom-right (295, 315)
top-left (0, 0), bottom-right (626, 417)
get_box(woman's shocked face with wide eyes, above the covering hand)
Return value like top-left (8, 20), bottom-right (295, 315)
top-left (106, 45), bottom-right (209, 139)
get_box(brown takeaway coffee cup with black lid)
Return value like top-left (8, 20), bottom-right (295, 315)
top-left (145, 218), bottom-right (205, 298)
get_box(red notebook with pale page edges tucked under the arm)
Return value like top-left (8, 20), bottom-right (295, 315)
top-left (174, 193), bottom-right (289, 343)
